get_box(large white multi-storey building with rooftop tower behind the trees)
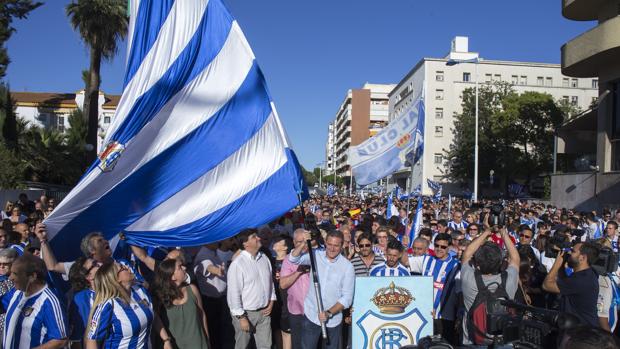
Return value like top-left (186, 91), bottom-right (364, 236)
top-left (389, 37), bottom-right (598, 195)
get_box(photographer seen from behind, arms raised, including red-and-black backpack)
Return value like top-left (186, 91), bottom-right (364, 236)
top-left (461, 228), bottom-right (521, 345)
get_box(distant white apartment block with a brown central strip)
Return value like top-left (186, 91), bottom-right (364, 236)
top-left (325, 83), bottom-right (395, 176)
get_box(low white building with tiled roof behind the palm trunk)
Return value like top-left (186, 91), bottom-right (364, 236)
top-left (11, 90), bottom-right (121, 149)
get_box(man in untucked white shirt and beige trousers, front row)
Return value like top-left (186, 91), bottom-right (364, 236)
top-left (226, 229), bottom-right (276, 349)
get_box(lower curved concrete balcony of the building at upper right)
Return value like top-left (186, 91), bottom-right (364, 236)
top-left (562, 16), bottom-right (620, 78)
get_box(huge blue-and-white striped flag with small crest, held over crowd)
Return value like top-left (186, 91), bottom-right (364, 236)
top-left (45, 0), bottom-right (307, 259)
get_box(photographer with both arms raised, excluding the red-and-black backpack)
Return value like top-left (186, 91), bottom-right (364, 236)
top-left (461, 228), bottom-right (521, 345)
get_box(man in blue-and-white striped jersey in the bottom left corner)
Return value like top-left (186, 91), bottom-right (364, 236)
top-left (2, 253), bottom-right (67, 349)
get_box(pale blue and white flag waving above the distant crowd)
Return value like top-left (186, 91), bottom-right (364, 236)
top-left (348, 94), bottom-right (424, 185)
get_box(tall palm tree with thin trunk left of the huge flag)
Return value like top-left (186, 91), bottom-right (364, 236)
top-left (66, 0), bottom-right (129, 163)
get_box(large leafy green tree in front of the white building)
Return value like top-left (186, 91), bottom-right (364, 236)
top-left (447, 83), bottom-right (566, 196)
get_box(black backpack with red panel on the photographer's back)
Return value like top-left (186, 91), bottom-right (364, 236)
top-left (467, 271), bottom-right (510, 345)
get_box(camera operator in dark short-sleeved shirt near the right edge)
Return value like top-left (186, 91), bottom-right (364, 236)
top-left (543, 242), bottom-right (599, 327)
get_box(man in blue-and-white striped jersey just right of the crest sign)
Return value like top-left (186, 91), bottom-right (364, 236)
top-left (407, 233), bottom-right (461, 343)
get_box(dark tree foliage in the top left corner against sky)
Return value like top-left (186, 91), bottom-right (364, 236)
top-left (0, 0), bottom-right (42, 79)
